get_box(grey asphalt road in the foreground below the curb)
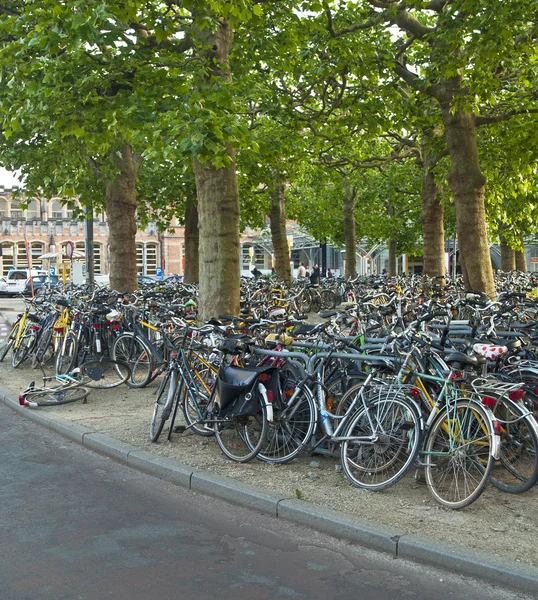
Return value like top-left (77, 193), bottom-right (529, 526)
top-left (0, 405), bottom-right (523, 600)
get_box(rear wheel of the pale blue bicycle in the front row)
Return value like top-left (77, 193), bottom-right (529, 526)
top-left (340, 389), bottom-right (421, 490)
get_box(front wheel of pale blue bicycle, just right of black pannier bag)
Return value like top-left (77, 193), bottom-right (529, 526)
top-left (254, 372), bottom-right (317, 463)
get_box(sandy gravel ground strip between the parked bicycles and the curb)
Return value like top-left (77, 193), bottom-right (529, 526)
top-left (0, 357), bottom-right (538, 566)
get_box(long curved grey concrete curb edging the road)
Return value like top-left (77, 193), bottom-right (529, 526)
top-left (0, 387), bottom-right (538, 594)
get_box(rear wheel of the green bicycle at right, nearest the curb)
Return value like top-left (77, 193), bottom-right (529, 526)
top-left (424, 400), bottom-right (495, 509)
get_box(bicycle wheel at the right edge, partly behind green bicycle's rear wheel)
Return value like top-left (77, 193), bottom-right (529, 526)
top-left (490, 398), bottom-right (538, 494)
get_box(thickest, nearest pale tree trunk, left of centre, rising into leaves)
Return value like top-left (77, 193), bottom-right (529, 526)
top-left (189, 19), bottom-right (240, 319)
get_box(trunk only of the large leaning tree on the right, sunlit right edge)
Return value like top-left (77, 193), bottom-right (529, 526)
top-left (441, 105), bottom-right (495, 298)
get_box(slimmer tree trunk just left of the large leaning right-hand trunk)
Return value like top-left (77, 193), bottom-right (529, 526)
top-left (421, 166), bottom-right (445, 285)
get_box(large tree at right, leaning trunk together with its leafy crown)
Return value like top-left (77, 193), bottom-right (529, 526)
top-left (318, 0), bottom-right (534, 296)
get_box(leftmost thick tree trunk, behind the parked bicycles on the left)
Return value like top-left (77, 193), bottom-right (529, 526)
top-left (106, 143), bottom-right (141, 292)
